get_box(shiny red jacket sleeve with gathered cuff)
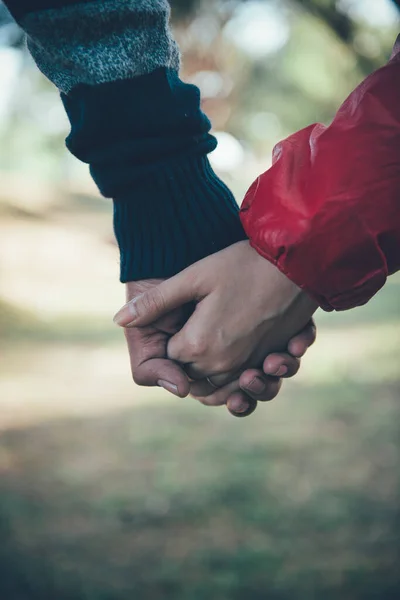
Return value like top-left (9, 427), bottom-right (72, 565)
top-left (241, 40), bottom-right (400, 310)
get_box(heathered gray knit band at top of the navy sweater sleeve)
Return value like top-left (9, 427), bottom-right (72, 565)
top-left (21, 0), bottom-right (179, 93)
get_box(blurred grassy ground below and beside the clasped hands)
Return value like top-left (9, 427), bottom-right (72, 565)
top-left (0, 195), bottom-right (400, 600)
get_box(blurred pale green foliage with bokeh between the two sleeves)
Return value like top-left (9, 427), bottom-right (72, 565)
top-left (172, 0), bottom-right (396, 155)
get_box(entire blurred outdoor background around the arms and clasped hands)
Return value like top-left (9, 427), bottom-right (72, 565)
top-left (0, 0), bottom-right (400, 600)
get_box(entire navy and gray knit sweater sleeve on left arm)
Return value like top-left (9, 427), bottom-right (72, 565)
top-left (5, 0), bottom-right (246, 282)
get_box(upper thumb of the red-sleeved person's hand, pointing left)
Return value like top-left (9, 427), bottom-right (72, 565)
top-left (114, 269), bottom-right (196, 327)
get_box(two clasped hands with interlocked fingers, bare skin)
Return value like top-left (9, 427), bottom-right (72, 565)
top-left (114, 241), bottom-right (318, 416)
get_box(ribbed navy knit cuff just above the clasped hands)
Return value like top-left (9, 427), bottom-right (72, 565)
top-left (114, 156), bottom-right (246, 283)
